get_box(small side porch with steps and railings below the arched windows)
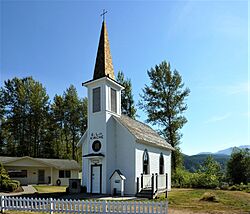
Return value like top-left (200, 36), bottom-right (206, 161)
top-left (136, 173), bottom-right (168, 199)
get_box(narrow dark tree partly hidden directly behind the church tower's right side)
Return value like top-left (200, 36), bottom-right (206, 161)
top-left (117, 71), bottom-right (136, 119)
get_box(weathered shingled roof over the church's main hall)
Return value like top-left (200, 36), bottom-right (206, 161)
top-left (113, 115), bottom-right (174, 150)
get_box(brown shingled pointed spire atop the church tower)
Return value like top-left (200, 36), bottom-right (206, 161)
top-left (93, 21), bottom-right (115, 80)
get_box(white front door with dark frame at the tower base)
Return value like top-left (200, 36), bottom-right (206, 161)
top-left (91, 164), bottom-right (102, 194)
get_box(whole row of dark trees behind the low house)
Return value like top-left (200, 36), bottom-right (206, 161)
top-left (0, 77), bottom-right (87, 160)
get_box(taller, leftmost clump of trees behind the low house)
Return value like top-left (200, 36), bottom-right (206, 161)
top-left (1, 77), bottom-right (49, 157)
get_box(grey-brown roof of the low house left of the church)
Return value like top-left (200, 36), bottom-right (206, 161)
top-left (0, 156), bottom-right (80, 170)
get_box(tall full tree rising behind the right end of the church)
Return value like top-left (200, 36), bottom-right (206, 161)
top-left (139, 61), bottom-right (190, 171)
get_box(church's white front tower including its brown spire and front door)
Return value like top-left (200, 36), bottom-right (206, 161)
top-left (82, 21), bottom-right (123, 193)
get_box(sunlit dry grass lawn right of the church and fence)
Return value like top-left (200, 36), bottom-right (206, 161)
top-left (168, 189), bottom-right (250, 214)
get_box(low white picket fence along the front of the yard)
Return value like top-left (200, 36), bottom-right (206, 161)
top-left (0, 196), bottom-right (168, 214)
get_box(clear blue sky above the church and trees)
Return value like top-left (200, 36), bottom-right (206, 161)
top-left (0, 0), bottom-right (250, 155)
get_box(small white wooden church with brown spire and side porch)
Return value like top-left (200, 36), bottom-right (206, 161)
top-left (78, 21), bottom-right (174, 197)
